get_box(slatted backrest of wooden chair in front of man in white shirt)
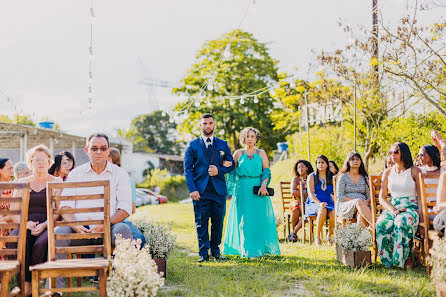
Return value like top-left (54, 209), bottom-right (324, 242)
top-left (47, 180), bottom-right (111, 261)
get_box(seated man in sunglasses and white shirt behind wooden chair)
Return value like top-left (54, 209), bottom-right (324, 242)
top-left (54, 133), bottom-right (133, 288)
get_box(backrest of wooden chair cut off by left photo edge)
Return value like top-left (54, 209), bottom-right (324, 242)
top-left (0, 182), bottom-right (29, 268)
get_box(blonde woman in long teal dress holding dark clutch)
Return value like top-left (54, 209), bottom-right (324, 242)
top-left (223, 127), bottom-right (280, 258)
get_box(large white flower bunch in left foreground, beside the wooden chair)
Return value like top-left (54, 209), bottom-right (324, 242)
top-left (107, 234), bottom-right (164, 297)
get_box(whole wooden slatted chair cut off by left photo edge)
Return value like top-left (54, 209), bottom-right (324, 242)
top-left (0, 183), bottom-right (29, 297)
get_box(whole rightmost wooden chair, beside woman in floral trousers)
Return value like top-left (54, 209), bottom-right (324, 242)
top-left (420, 173), bottom-right (443, 273)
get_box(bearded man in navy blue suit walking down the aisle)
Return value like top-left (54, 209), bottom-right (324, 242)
top-left (184, 114), bottom-right (234, 263)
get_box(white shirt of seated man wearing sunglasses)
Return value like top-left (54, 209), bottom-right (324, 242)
top-left (59, 161), bottom-right (132, 221)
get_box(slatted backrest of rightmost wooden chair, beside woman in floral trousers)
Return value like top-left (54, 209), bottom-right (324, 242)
top-left (419, 173), bottom-right (440, 234)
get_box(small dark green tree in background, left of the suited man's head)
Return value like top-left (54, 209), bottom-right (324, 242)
top-left (126, 110), bottom-right (183, 154)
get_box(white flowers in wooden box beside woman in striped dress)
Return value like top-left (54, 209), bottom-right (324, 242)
top-left (335, 222), bottom-right (372, 251)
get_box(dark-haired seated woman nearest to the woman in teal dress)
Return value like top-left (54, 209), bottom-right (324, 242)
top-left (288, 160), bottom-right (314, 242)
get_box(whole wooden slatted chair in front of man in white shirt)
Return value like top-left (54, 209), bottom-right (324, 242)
top-left (30, 180), bottom-right (111, 297)
